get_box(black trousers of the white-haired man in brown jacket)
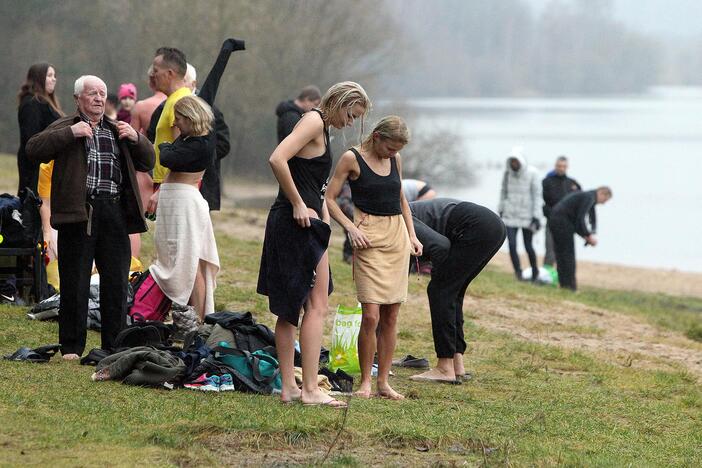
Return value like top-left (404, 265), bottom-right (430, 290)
top-left (58, 198), bottom-right (131, 355)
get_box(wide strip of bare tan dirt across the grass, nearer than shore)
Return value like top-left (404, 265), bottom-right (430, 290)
top-left (465, 297), bottom-right (702, 377)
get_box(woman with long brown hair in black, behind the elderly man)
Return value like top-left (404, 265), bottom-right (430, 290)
top-left (17, 62), bottom-right (64, 199)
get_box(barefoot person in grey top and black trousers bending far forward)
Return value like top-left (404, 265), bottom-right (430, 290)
top-left (409, 198), bottom-right (507, 383)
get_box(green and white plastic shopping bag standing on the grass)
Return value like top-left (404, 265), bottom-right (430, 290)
top-left (329, 304), bottom-right (362, 374)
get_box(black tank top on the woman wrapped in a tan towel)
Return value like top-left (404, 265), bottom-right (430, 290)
top-left (349, 148), bottom-right (402, 216)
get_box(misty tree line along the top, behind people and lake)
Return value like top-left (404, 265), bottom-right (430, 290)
top-left (0, 0), bottom-right (702, 181)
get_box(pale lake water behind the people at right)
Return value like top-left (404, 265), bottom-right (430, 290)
top-left (411, 89), bottom-right (702, 272)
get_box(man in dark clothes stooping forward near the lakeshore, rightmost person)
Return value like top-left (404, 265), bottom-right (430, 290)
top-left (548, 186), bottom-right (612, 291)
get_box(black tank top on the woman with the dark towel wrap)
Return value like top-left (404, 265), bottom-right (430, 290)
top-left (271, 109), bottom-right (332, 218)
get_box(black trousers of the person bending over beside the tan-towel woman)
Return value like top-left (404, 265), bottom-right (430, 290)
top-left (427, 202), bottom-right (505, 358)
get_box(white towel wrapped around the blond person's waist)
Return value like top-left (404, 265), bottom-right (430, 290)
top-left (149, 183), bottom-right (219, 314)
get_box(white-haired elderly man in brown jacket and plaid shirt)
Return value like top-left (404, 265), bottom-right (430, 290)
top-left (27, 75), bottom-right (154, 359)
